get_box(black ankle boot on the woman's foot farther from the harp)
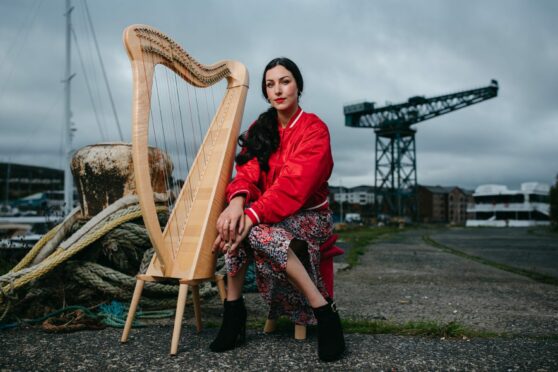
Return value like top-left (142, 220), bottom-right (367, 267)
top-left (312, 298), bottom-right (345, 362)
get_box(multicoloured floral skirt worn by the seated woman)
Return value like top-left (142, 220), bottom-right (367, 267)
top-left (225, 208), bottom-right (333, 325)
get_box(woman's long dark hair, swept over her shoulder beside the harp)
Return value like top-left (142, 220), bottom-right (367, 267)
top-left (235, 57), bottom-right (304, 171)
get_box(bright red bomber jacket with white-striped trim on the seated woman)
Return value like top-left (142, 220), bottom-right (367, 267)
top-left (226, 108), bottom-right (333, 225)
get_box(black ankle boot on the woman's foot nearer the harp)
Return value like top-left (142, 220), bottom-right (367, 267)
top-left (209, 297), bottom-right (246, 352)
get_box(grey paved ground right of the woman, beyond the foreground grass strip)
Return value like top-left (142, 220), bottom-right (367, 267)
top-left (336, 229), bottom-right (558, 336)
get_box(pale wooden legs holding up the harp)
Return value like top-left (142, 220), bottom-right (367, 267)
top-left (120, 275), bottom-right (229, 355)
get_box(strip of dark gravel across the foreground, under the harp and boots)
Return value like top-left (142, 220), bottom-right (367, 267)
top-left (1, 326), bottom-right (558, 371)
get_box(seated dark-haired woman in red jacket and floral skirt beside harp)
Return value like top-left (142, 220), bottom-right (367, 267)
top-left (210, 58), bottom-right (345, 361)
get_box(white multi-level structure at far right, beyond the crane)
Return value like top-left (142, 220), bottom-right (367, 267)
top-left (466, 182), bottom-right (550, 227)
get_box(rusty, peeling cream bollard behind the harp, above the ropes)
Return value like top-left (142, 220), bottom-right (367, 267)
top-left (71, 143), bottom-right (173, 218)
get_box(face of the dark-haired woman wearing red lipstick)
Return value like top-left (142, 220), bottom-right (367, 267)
top-left (265, 65), bottom-right (298, 112)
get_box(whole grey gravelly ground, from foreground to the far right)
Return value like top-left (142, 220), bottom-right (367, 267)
top-left (0, 225), bottom-right (558, 371)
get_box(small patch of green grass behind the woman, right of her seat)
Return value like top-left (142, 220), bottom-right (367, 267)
top-left (338, 227), bottom-right (401, 267)
